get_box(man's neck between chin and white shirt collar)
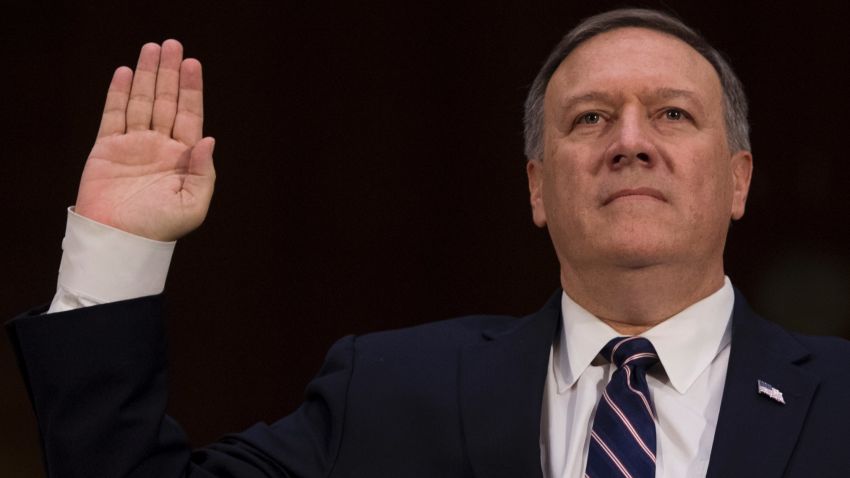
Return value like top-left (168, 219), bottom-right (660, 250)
top-left (561, 261), bottom-right (724, 335)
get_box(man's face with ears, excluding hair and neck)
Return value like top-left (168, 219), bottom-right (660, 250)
top-left (528, 28), bottom-right (752, 274)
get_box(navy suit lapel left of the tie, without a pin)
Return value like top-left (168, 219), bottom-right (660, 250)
top-left (459, 292), bottom-right (561, 478)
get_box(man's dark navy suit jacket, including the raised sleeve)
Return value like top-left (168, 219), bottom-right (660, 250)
top-left (9, 292), bottom-right (850, 478)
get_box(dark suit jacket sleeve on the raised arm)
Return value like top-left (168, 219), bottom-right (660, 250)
top-left (7, 296), bottom-right (355, 478)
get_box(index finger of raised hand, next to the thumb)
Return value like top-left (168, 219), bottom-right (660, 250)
top-left (173, 58), bottom-right (204, 146)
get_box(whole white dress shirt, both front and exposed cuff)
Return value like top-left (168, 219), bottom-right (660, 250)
top-left (48, 208), bottom-right (734, 478)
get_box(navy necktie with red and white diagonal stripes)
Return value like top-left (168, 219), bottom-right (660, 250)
top-left (584, 337), bottom-right (658, 478)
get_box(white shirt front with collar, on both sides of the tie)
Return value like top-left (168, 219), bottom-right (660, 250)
top-left (540, 277), bottom-right (735, 478)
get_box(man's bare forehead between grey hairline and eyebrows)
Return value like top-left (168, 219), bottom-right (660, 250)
top-left (546, 27), bottom-right (722, 108)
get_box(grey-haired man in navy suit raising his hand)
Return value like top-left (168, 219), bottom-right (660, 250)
top-left (10, 10), bottom-right (850, 477)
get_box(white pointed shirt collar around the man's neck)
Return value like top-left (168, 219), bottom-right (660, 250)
top-left (553, 277), bottom-right (735, 393)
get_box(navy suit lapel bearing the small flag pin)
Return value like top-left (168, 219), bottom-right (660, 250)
top-left (706, 290), bottom-right (818, 478)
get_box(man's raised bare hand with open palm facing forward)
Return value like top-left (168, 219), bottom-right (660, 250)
top-left (75, 40), bottom-right (215, 241)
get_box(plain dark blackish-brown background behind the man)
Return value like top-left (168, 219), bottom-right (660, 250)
top-left (0, 1), bottom-right (850, 477)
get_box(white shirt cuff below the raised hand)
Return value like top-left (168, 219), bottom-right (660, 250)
top-left (48, 207), bottom-right (176, 312)
